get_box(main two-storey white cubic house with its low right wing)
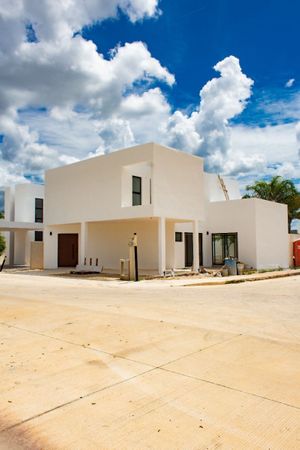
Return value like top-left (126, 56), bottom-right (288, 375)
top-left (0, 143), bottom-right (289, 274)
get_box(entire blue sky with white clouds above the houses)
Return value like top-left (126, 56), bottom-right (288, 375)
top-left (0, 0), bottom-right (300, 201)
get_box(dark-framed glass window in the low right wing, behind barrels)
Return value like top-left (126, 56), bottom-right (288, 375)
top-left (212, 233), bottom-right (238, 265)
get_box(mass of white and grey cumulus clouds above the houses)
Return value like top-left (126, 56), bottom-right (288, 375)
top-left (0, 0), bottom-right (300, 193)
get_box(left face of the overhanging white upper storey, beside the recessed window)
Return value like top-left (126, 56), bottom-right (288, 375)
top-left (45, 144), bottom-right (153, 225)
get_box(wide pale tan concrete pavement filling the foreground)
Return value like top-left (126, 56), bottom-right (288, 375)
top-left (0, 273), bottom-right (300, 450)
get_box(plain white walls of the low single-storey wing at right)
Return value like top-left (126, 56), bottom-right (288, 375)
top-left (208, 198), bottom-right (289, 269)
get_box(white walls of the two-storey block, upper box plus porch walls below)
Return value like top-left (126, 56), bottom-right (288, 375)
top-left (45, 144), bottom-right (204, 270)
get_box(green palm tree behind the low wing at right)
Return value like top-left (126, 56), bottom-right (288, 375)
top-left (243, 176), bottom-right (300, 232)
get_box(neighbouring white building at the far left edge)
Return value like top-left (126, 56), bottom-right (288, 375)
top-left (0, 183), bottom-right (44, 266)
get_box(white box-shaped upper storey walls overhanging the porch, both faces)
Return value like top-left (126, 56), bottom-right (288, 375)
top-left (45, 143), bottom-right (204, 225)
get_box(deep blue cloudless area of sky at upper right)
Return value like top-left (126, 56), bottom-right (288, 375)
top-left (83, 0), bottom-right (300, 119)
